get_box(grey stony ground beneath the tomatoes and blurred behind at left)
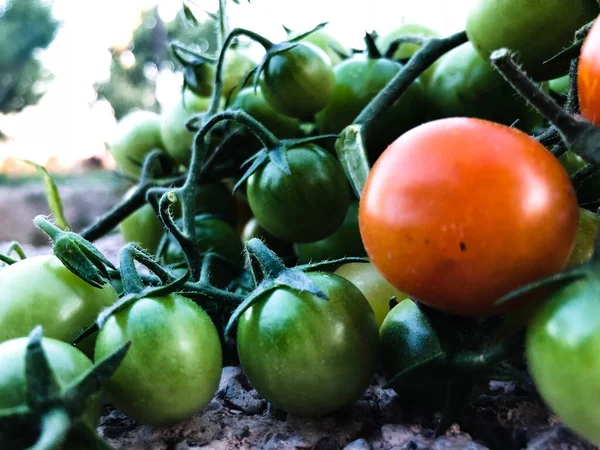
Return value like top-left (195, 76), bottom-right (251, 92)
top-left (0, 181), bottom-right (597, 450)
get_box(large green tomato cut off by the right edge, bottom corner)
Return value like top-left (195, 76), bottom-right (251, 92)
top-left (526, 274), bottom-right (600, 444)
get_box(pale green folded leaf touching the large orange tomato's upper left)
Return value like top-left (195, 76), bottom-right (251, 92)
top-left (335, 125), bottom-right (371, 198)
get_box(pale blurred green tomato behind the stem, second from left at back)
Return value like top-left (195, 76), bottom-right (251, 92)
top-left (160, 90), bottom-right (210, 165)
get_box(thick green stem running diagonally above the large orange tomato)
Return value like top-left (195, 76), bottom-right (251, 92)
top-left (354, 31), bottom-right (467, 140)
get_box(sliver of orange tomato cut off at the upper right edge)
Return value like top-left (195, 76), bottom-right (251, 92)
top-left (577, 15), bottom-right (600, 127)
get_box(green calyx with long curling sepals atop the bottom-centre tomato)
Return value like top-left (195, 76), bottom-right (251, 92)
top-left (224, 238), bottom-right (368, 340)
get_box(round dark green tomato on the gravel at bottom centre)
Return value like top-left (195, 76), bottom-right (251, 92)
top-left (237, 272), bottom-right (379, 416)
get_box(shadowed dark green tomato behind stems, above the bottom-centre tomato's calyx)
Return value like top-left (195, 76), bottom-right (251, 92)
top-left (163, 216), bottom-right (244, 265)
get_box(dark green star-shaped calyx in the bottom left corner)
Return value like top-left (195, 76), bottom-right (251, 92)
top-left (0, 326), bottom-right (131, 449)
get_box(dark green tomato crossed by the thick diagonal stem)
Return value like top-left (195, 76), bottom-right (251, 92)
top-left (316, 55), bottom-right (429, 161)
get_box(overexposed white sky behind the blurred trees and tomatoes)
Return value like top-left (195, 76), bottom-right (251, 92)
top-left (0, 0), bottom-right (475, 171)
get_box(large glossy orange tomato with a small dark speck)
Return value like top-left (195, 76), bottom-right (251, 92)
top-left (359, 118), bottom-right (578, 316)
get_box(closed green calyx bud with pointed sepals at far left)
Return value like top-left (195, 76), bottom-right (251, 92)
top-left (33, 215), bottom-right (115, 288)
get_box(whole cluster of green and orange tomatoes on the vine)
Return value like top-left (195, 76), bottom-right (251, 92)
top-left (0, 0), bottom-right (600, 442)
